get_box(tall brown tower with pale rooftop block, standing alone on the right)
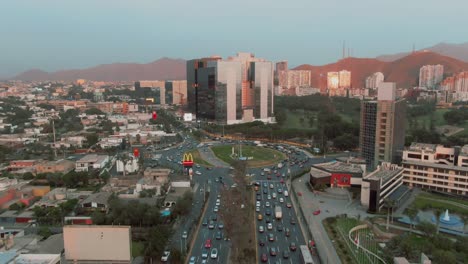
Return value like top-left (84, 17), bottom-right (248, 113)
top-left (359, 82), bottom-right (406, 170)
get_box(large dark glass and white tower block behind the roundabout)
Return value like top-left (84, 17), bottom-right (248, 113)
top-left (187, 53), bottom-right (274, 124)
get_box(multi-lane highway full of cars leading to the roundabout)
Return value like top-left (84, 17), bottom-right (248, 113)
top-left (148, 131), bottom-right (352, 264)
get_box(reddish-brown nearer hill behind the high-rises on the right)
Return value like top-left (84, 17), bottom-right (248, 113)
top-left (295, 52), bottom-right (468, 88)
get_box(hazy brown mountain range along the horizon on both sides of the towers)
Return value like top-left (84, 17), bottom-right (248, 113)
top-left (11, 43), bottom-right (468, 87)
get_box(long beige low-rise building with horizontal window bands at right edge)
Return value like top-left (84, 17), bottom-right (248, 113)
top-left (402, 143), bottom-right (468, 196)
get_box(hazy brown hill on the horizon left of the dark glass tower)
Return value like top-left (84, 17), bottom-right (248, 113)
top-left (12, 58), bottom-right (186, 81)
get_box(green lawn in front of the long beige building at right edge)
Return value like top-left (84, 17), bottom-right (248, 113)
top-left (410, 193), bottom-right (468, 215)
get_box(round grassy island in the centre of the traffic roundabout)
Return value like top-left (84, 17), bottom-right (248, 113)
top-left (211, 145), bottom-right (286, 167)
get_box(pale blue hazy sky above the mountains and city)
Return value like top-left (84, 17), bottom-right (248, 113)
top-left (0, 0), bottom-right (468, 77)
